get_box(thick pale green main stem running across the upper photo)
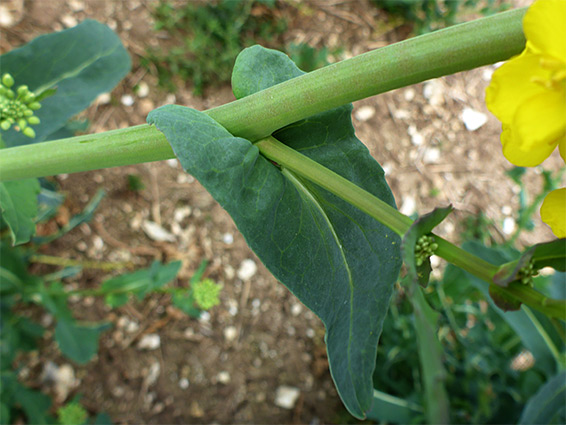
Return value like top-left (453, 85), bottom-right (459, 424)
top-left (0, 9), bottom-right (525, 181)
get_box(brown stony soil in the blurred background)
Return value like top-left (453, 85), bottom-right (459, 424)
top-left (0, 0), bottom-right (560, 424)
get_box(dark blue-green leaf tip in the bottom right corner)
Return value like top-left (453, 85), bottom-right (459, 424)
top-left (519, 372), bottom-right (566, 425)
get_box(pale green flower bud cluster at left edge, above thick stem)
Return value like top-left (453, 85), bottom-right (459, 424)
top-left (0, 74), bottom-right (41, 138)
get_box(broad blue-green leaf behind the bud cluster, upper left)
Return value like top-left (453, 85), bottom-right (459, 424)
top-left (0, 20), bottom-right (131, 146)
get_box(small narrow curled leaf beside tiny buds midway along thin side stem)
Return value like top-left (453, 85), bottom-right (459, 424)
top-left (401, 206), bottom-right (454, 287)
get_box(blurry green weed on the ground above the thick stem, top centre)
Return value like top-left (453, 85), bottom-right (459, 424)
top-left (142, 0), bottom-right (287, 94)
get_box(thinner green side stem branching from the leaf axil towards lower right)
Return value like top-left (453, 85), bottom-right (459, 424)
top-left (255, 137), bottom-right (566, 319)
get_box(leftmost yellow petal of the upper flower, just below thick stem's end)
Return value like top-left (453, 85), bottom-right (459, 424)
top-left (485, 52), bottom-right (550, 124)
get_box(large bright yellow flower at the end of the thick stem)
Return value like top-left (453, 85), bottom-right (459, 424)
top-left (486, 0), bottom-right (566, 167)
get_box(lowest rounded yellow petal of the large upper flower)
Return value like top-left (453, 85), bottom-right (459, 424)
top-left (501, 90), bottom-right (566, 167)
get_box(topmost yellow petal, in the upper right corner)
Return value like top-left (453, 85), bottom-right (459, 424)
top-left (523, 0), bottom-right (566, 62)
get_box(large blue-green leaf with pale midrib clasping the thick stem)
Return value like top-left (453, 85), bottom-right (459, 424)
top-left (148, 46), bottom-right (401, 418)
